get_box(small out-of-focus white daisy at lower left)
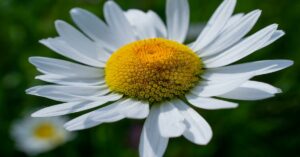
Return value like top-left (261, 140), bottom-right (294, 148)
top-left (11, 117), bottom-right (73, 155)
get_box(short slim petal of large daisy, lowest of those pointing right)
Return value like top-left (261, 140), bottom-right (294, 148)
top-left (185, 93), bottom-right (238, 110)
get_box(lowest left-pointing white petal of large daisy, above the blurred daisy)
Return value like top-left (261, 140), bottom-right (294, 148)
top-left (64, 101), bottom-right (125, 131)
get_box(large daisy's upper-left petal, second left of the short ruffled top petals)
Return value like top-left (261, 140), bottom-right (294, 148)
top-left (71, 8), bottom-right (122, 51)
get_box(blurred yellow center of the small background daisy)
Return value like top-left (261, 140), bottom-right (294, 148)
top-left (33, 123), bottom-right (56, 139)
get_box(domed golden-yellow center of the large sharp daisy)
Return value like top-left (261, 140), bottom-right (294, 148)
top-left (105, 38), bottom-right (202, 102)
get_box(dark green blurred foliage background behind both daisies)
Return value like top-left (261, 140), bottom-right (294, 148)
top-left (0, 0), bottom-right (300, 157)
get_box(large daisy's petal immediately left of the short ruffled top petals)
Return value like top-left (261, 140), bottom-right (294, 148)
top-left (104, 1), bottom-right (135, 44)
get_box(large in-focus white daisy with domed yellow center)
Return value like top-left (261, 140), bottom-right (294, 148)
top-left (27, 0), bottom-right (292, 157)
